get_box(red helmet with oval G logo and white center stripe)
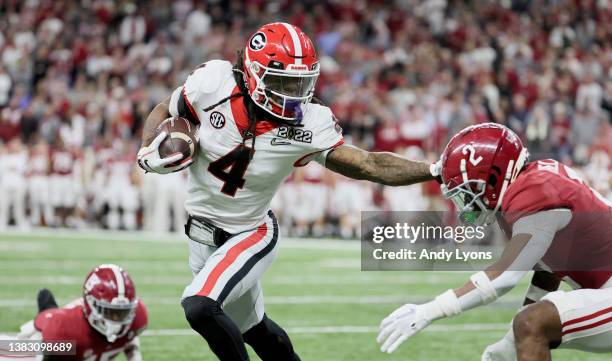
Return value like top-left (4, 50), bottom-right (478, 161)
top-left (243, 23), bottom-right (319, 124)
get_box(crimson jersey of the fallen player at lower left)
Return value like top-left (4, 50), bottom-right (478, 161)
top-left (34, 300), bottom-right (147, 361)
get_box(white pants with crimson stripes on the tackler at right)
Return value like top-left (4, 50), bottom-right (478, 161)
top-left (482, 281), bottom-right (612, 361)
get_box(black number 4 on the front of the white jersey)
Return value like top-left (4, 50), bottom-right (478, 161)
top-left (208, 144), bottom-right (255, 197)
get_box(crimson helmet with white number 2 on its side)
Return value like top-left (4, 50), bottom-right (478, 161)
top-left (441, 123), bottom-right (529, 225)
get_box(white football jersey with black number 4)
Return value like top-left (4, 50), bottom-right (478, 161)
top-left (169, 60), bottom-right (343, 233)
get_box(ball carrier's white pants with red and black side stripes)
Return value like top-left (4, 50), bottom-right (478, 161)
top-left (183, 211), bottom-right (279, 333)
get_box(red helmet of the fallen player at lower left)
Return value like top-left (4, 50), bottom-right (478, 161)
top-left (83, 264), bottom-right (138, 342)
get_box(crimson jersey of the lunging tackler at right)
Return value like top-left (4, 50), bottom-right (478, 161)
top-left (501, 159), bottom-right (612, 288)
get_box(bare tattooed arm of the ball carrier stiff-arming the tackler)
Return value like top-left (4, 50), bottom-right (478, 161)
top-left (325, 145), bottom-right (439, 186)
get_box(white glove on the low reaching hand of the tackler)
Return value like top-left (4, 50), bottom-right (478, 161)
top-left (376, 304), bottom-right (432, 353)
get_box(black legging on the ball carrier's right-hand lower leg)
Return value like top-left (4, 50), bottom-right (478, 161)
top-left (242, 315), bottom-right (300, 361)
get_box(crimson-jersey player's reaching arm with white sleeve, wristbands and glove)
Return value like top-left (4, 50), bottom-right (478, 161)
top-left (377, 209), bottom-right (572, 353)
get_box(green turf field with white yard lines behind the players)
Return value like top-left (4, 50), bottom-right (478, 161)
top-left (0, 231), bottom-right (609, 361)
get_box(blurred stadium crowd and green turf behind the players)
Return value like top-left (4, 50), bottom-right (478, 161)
top-left (0, 0), bottom-right (612, 360)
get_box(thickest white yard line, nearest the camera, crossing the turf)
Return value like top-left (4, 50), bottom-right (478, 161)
top-left (0, 323), bottom-right (510, 337)
